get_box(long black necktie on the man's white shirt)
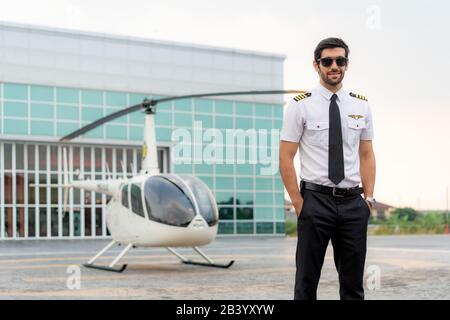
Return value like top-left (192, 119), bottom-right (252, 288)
top-left (328, 94), bottom-right (345, 185)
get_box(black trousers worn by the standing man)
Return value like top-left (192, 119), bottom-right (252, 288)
top-left (294, 190), bottom-right (370, 300)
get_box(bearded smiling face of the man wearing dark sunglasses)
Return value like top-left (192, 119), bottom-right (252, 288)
top-left (314, 48), bottom-right (348, 86)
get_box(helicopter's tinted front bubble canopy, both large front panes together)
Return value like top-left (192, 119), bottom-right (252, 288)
top-left (143, 174), bottom-right (219, 227)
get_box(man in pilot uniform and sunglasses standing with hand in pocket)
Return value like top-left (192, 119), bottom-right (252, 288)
top-left (280, 38), bottom-right (375, 300)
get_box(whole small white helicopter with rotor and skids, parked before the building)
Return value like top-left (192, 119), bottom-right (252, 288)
top-left (30, 90), bottom-right (306, 272)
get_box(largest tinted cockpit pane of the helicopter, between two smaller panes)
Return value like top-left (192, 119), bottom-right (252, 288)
top-left (144, 176), bottom-right (195, 227)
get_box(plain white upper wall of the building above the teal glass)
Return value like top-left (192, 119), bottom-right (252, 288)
top-left (0, 23), bottom-right (284, 103)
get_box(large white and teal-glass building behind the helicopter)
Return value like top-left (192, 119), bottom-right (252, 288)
top-left (0, 23), bottom-right (285, 239)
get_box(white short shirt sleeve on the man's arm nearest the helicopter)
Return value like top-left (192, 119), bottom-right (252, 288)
top-left (280, 100), bottom-right (304, 143)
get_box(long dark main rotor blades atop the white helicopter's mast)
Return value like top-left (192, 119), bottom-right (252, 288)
top-left (59, 90), bottom-right (306, 142)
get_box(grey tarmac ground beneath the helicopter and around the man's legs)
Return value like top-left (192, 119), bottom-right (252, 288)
top-left (0, 235), bottom-right (450, 300)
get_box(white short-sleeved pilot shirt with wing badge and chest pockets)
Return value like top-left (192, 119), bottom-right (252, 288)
top-left (280, 85), bottom-right (373, 188)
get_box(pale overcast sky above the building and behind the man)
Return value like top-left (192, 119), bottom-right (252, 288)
top-left (0, 0), bottom-right (450, 210)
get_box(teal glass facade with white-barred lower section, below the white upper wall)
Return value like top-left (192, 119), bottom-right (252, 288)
top-left (0, 83), bottom-right (285, 239)
